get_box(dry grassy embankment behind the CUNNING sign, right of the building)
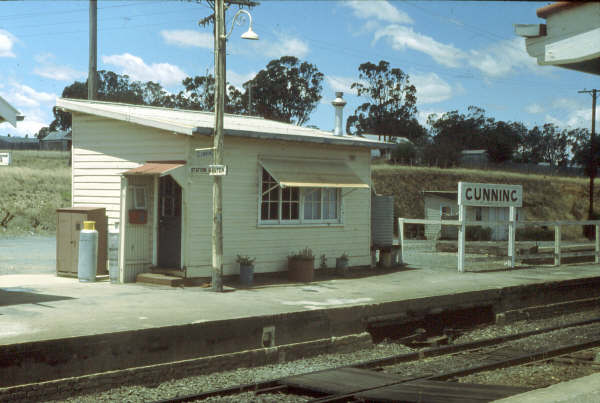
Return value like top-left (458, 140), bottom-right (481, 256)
top-left (373, 164), bottom-right (600, 237)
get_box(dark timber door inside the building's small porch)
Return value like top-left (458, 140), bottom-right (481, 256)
top-left (158, 175), bottom-right (181, 269)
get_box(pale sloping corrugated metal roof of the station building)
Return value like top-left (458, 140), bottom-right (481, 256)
top-left (56, 98), bottom-right (395, 148)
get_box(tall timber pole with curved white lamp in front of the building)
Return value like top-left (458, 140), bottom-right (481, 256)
top-left (212, 0), bottom-right (258, 292)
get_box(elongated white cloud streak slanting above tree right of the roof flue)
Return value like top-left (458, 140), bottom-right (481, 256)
top-left (373, 25), bottom-right (465, 67)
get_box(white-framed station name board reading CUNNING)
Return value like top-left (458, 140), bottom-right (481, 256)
top-left (458, 182), bottom-right (523, 207)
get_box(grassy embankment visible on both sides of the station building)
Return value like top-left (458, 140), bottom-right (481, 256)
top-left (0, 151), bottom-right (600, 235)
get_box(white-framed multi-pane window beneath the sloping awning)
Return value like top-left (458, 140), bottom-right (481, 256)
top-left (260, 168), bottom-right (340, 224)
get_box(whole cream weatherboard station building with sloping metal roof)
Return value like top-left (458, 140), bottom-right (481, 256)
top-left (57, 99), bottom-right (389, 282)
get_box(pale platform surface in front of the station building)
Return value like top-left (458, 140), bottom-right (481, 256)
top-left (0, 264), bottom-right (600, 345)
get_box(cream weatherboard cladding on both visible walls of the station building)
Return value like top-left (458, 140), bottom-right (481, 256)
top-left (72, 113), bottom-right (371, 279)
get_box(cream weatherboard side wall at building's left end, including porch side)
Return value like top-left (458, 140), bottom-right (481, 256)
top-left (71, 113), bottom-right (187, 282)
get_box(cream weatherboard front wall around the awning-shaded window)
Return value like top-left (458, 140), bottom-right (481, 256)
top-left (187, 136), bottom-right (371, 276)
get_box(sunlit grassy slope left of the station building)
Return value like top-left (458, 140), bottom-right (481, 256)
top-left (0, 150), bottom-right (71, 234)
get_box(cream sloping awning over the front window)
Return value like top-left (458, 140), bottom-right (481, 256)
top-left (259, 158), bottom-right (369, 189)
